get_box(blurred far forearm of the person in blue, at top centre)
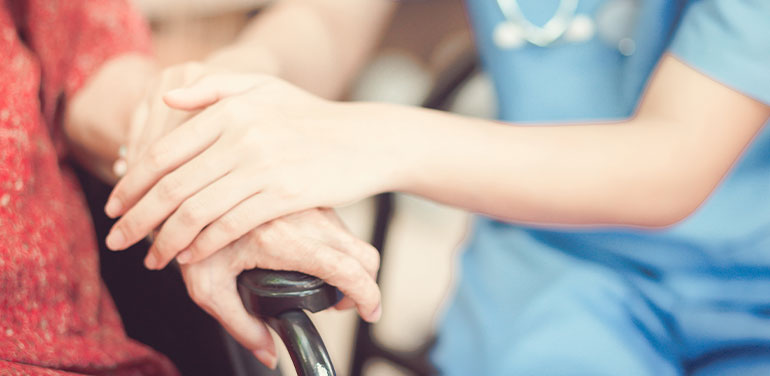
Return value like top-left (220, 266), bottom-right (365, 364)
top-left (207, 0), bottom-right (395, 98)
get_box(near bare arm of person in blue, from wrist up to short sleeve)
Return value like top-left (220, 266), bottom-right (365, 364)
top-left (378, 56), bottom-right (770, 227)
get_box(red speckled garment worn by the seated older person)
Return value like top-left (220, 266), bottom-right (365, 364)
top-left (0, 0), bottom-right (177, 375)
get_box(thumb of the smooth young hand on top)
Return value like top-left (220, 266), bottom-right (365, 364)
top-left (163, 74), bottom-right (262, 111)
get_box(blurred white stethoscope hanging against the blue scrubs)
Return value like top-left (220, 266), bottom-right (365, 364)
top-left (492, 0), bottom-right (638, 56)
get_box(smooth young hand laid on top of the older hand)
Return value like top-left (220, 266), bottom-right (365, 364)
top-left (105, 74), bottom-right (391, 268)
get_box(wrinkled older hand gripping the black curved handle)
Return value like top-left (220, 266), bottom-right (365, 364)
top-left (181, 209), bottom-right (381, 368)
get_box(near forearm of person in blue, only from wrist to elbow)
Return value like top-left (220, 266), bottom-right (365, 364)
top-left (367, 105), bottom-right (712, 227)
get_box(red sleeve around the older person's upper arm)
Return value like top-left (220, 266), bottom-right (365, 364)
top-left (18, 0), bottom-right (151, 123)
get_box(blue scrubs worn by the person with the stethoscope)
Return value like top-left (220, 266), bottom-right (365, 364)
top-left (433, 0), bottom-right (770, 375)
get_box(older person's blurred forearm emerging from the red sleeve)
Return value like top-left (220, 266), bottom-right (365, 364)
top-left (64, 55), bottom-right (156, 182)
